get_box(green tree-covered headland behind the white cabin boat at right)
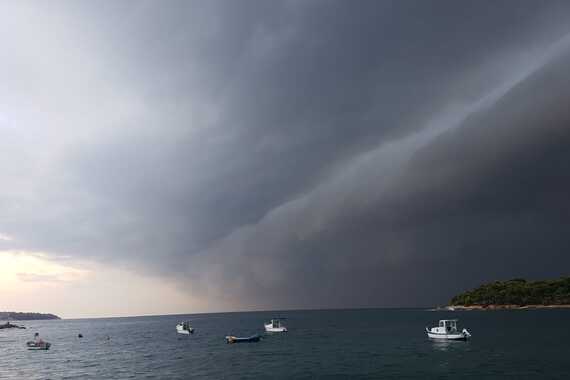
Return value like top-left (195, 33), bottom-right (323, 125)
top-left (448, 277), bottom-right (570, 310)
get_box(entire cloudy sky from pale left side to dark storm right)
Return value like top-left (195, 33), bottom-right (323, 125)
top-left (0, 0), bottom-right (570, 316)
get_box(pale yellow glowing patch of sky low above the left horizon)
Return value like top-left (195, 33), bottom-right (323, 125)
top-left (0, 251), bottom-right (207, 318)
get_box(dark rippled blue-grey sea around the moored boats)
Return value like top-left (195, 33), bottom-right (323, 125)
top-left (0, 309), bottom-right (570, 379)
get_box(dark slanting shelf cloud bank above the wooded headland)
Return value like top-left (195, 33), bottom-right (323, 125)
top-left (181, 42), bottom-right (570, 307)
